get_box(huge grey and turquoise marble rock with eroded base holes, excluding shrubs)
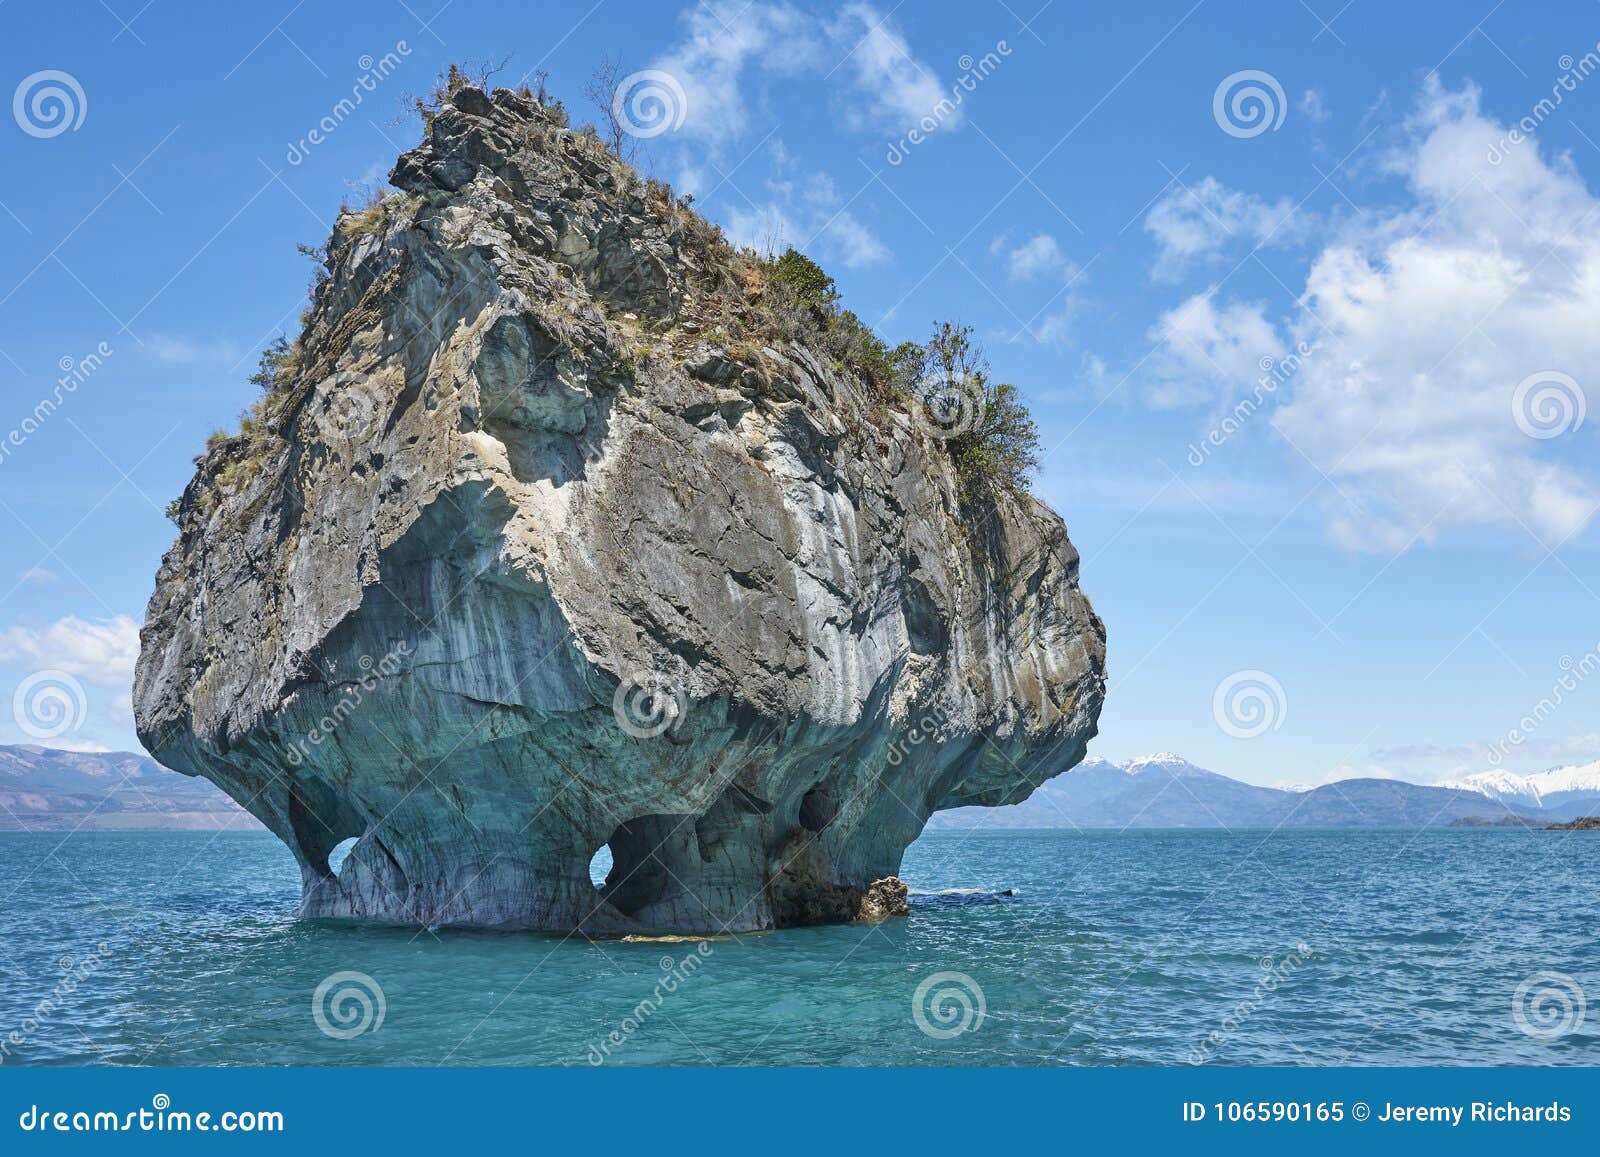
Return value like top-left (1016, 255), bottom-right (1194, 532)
top-left (134, 88), bottom-right (1104, 935)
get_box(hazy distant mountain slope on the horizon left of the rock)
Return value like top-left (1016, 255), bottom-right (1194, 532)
top-left (0, 744), bottom-right (261, 832)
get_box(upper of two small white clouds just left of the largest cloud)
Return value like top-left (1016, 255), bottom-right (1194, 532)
top-left (1144, 176), bottom-right (1315, 280)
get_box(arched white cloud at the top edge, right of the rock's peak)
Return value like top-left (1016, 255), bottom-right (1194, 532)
top-left (651, 0), bottom-right (960, 147)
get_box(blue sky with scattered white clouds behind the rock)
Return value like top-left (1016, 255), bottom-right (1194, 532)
top-left (0, 0), bottom-right (1600, 783)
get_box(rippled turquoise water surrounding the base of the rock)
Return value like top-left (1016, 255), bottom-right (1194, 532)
top-left (0, 831), bottom-right (1600, 1064)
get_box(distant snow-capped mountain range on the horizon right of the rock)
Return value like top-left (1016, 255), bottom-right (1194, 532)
top-left (928, 752), bottom-right (1600, 827)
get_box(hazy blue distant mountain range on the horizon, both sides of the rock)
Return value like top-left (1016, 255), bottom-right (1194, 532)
top-left (0, 744), bottom-right (1600, 832)
